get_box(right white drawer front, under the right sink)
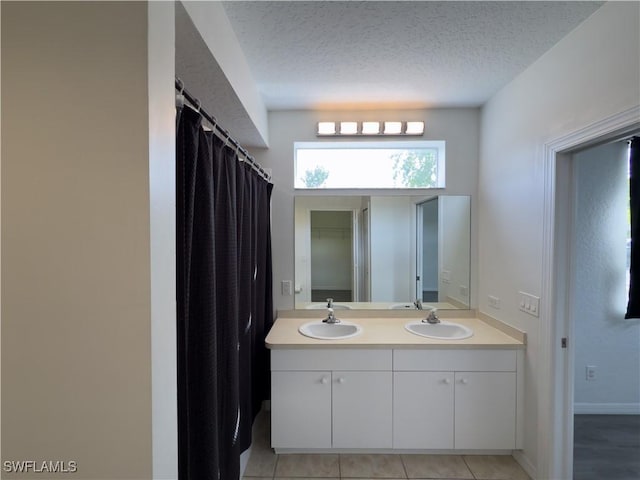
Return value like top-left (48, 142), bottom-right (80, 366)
top-left (393, 349), bottom-right (517, 372)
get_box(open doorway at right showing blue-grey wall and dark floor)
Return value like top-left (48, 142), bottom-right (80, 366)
top-left (568, 141), bottom-right (640, 480)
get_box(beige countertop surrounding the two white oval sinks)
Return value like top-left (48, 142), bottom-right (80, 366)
top-left (265, 311), bottom-right (526, 349)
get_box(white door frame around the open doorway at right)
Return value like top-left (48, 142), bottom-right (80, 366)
top-left (537, 106), bottom-right (640, 479)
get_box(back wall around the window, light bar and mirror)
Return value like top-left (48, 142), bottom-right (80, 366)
top-left (251, 108), bottom-right (480, 310)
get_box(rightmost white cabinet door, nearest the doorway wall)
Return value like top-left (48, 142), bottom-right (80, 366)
top-left (455, 372), bottom-right (516, 450)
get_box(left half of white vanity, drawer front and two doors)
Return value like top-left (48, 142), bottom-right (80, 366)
top-left (271, 349), bottom-right (393, 450)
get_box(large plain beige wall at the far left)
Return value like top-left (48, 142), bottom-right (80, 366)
top-left (1, 2), bottom-right (152, 480)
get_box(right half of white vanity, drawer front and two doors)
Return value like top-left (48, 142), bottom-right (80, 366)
top-left (393, 349), bottom-right (522, 450)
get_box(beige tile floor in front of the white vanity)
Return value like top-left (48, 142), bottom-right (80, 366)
top-left (243, 412), bottom-right (529, 480)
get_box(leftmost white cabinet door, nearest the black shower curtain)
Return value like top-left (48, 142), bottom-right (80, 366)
top-left (271, 371), bottom-right (331, 448)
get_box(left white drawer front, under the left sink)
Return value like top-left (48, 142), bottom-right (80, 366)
top-left (271, 348), bottom-right (392, 371)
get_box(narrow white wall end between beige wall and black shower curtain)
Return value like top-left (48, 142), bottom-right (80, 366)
top-left (148, 2), bottom-right (178, 480)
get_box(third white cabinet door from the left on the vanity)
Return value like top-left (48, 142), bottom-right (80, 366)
top-left (393, 372), bottom-right (454, 449)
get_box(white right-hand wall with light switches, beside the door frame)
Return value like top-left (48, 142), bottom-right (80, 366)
top-left (478, 2), bottom-right (640, 478)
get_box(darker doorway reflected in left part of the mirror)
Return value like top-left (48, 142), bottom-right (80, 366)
top-left (310, 210), bottom-right (354, 302)
